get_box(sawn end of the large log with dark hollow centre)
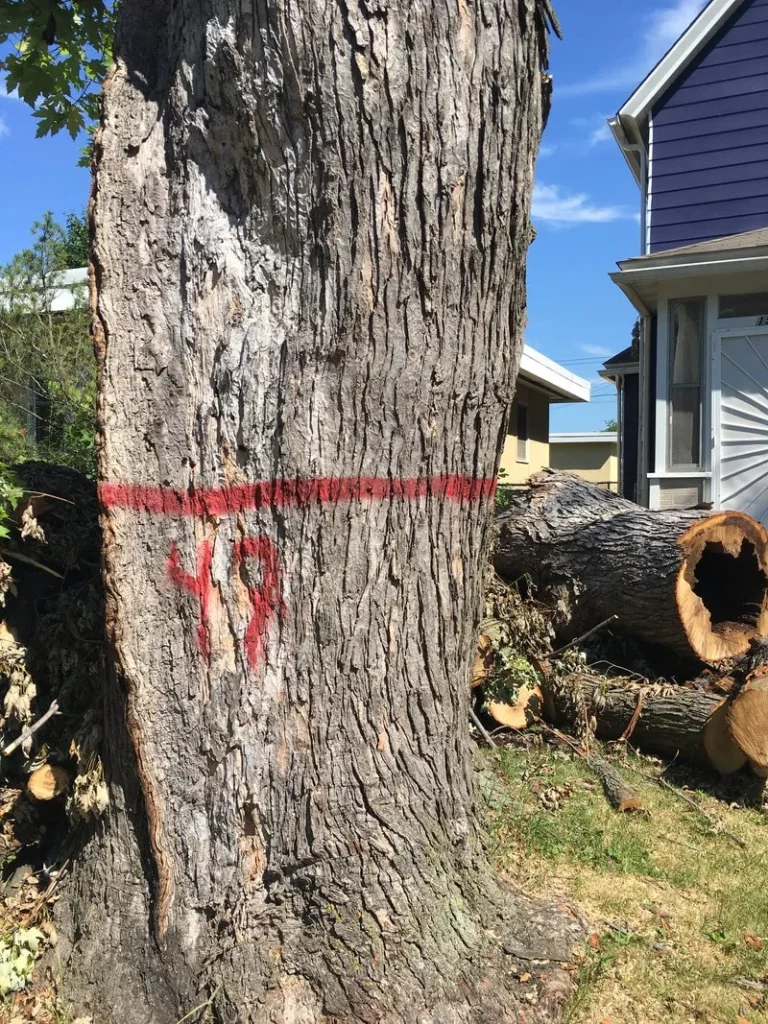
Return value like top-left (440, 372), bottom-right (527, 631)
top-left (677, 512), bottom-right (768, 664)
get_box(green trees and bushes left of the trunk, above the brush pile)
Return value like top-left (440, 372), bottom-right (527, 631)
top-left (0, 213), bottom-right (96, 475)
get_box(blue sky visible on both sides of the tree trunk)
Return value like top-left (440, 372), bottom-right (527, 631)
top-left (0, 0), bottom-right (706, 430)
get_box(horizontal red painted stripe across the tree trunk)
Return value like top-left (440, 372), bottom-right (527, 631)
top-left (99, 475), bottom-right (497, 516)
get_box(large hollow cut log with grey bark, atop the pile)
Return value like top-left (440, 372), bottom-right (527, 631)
top-left (495, 470), bottom-right (768, 664)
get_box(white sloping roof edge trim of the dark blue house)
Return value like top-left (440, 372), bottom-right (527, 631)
top-left (608, 0), bottom-right (745, 180)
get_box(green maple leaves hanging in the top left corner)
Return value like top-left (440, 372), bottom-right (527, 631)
top-left (0, 0), bottom-right (115, 153)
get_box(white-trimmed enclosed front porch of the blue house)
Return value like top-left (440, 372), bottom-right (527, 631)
top-left (602, 228), bottom-right (768, 523)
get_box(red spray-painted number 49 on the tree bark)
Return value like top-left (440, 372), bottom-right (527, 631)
top-left (167, 537), bottom-right (285, 668)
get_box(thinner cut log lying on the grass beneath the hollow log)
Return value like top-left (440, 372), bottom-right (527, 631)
top-left (545, 674), bottom-right (746, 775)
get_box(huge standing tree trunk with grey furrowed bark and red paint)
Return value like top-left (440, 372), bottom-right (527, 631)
top-left (55, 0), bottom-right (574, 1024)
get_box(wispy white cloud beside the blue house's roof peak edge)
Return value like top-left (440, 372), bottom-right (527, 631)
top-left (556, 0), bottom-right (708, 96)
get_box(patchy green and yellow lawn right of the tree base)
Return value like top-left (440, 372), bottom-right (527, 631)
top-left (483, 750), bottom-right (768, 1024)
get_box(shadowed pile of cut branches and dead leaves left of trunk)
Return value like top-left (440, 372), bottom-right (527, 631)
top-left (0, 463), bottom-right (108, 1024)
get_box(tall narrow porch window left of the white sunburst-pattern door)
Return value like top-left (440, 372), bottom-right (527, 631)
top-left (670, 299), bottom-right (707, 469)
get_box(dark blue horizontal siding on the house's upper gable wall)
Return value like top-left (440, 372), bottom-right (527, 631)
top-left (649, 0), bottom-right (768, 252)
